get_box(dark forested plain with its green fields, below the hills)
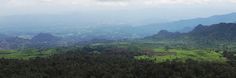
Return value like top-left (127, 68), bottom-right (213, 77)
top-left (0, 40), bottom-right (236, 78)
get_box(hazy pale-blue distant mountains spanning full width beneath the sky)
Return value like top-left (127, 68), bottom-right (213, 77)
top-left (0, 13), bottom-right (236, 40)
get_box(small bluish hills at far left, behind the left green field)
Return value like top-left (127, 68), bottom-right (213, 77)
top-left (0, 33), bottom-right (61, 49)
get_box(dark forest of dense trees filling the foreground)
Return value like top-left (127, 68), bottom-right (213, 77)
top-left (0, 47), bottom-right (236, 78)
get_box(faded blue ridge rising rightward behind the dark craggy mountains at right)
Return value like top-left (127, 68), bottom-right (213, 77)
top-left (73, 13), bottom-right (236, 38)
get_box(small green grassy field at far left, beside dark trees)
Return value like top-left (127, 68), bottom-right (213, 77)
top-left (0, 49), bottom-right (55, 59)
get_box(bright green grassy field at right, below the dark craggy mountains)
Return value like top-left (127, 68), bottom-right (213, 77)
top-left (135, 48), bottom-right (225, 63)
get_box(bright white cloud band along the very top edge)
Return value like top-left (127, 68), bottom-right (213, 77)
top-left (0, 0), bottom-right (236, 9)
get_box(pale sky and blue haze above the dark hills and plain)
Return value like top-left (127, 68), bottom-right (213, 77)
top-left (0, 0), bottom-right (236, 37)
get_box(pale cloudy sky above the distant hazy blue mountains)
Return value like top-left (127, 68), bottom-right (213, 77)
top-left (0, 0), bottom-right (236, 20)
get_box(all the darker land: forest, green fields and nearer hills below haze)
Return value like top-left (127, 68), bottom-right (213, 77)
top-left (0, 23), bottom-right (236, 78)
